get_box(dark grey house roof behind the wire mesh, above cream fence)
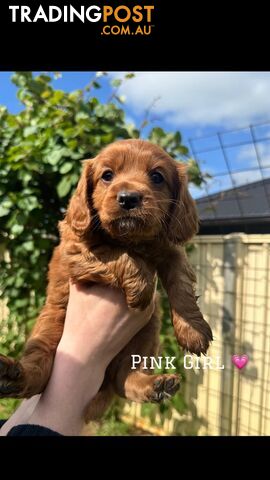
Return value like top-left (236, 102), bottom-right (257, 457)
top-left (196, 178), bottom-right (270, 225)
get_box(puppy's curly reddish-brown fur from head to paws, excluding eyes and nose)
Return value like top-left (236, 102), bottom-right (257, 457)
top-left (0, 140), bottom-right (212, 420)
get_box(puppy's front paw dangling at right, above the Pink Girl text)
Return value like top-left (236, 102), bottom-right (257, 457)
top-left (173, 317), bottom-right (213, 355)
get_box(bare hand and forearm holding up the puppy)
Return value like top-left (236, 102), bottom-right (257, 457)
top-left (0, 284), bottom-right (154, 435)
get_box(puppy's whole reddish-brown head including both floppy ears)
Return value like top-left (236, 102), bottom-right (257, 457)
top-left (67, 140), bottom-right (197, 243)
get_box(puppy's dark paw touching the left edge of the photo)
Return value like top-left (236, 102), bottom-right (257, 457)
top-left (0, 355), bottom-right (25, 398)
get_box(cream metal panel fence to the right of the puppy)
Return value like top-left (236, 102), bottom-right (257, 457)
top-left (185, 234), bottom-right (270, 435)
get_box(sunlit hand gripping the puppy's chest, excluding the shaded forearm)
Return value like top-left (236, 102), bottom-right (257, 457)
top-left (58, 284), bottom-right (154, 371)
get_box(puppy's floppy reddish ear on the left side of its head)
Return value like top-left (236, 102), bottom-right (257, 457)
top-left (66, 160), bottom-right (93, 237)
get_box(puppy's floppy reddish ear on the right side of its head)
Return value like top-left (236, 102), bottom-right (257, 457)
top-left (168, 162), bottom-right (199, 244)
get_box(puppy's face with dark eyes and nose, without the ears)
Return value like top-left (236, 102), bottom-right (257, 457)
top-left (92, 142), bottom-right (176, 241)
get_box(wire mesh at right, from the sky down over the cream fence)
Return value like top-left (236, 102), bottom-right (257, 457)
top-left (185, 123), bottom-right (270, 435)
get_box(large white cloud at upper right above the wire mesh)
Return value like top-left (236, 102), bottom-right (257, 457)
top-left (112, 72), bottom-right (270, 128)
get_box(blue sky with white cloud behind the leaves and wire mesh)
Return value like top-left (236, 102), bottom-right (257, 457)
top-left (0, 72), bottom-right (270, 197)
